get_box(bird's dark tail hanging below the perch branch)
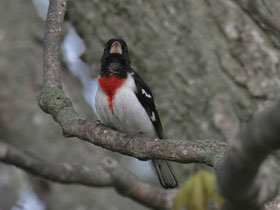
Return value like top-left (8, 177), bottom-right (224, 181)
top-left (153, 160), bottom-right (178, 189)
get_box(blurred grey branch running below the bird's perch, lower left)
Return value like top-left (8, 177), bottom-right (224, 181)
top-left (0, 142), bottom-right (172, 210)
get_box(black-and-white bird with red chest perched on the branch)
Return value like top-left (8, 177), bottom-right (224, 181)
top-left (95, 39), bottom-right (177, 189)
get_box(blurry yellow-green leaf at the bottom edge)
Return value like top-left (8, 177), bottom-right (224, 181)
top-left (173, 171), bottom-right (223, 210)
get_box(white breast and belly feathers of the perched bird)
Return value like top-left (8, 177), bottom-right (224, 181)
top-left (95, 74), bottom-right (156, 137)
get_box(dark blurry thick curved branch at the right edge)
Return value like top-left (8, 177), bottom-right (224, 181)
top-left (217, 100), bottom-right (280, 210)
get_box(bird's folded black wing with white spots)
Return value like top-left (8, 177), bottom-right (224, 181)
top-left (130, 69), bottom-right (163, 138)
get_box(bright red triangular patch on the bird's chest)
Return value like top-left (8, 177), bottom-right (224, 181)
top-left (98, 74), bottom-right (126, 114)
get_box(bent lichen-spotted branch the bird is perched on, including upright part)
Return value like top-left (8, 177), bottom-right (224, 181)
top-left (38, 0), bottom-right (226, 166)
